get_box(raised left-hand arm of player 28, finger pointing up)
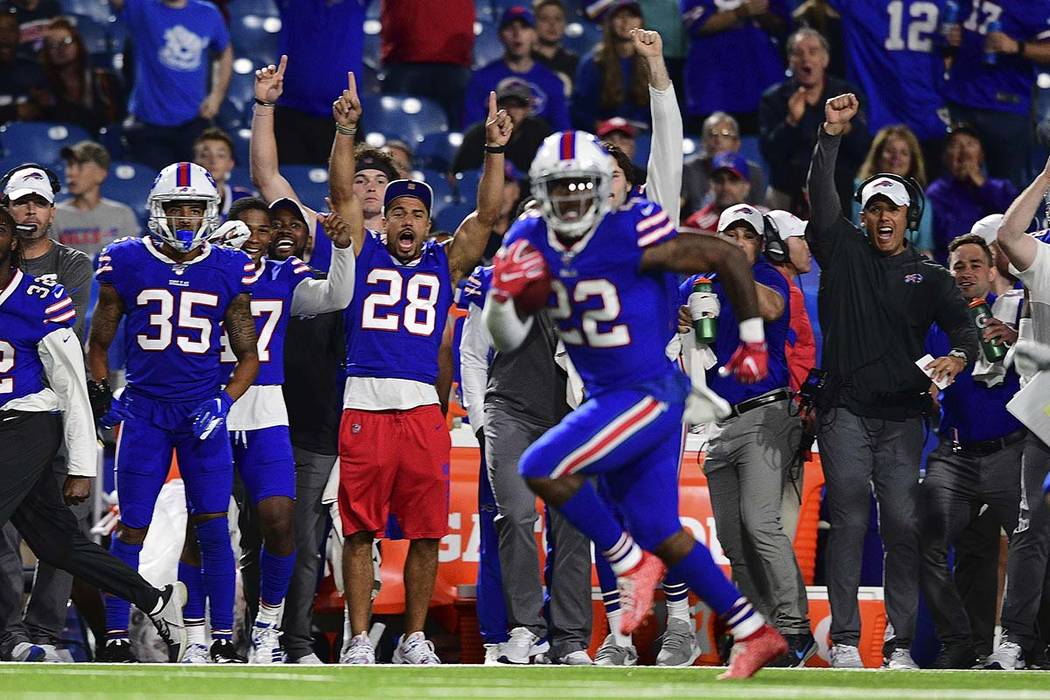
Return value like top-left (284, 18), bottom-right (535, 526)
top-left (329, 72), bottom-right (365, 255)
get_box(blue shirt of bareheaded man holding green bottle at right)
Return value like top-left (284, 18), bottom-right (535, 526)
top-left (926, 294), bottom-right (1024, 443)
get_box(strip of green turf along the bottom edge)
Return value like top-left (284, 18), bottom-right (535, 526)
top-left (0, 663), bottom-right (1050, 700)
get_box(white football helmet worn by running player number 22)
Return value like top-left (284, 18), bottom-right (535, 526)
top-left (528, 131), bottom-right (613, 238)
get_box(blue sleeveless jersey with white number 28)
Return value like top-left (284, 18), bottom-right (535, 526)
top-left (344, 231), bottom-right (453, 384)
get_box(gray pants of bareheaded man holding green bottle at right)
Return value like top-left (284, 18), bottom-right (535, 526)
top-left (920, 441), bottom-right (1024, 644)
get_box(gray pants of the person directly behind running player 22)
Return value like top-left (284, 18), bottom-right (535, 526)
top-left (485, 403), bottom-right (591, 658)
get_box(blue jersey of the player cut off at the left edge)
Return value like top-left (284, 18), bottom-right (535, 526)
top-left (0, 270), bottom-right (77, 407)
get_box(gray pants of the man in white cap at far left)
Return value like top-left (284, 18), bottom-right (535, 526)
top-left (0, 465), bottom-right (91, 659)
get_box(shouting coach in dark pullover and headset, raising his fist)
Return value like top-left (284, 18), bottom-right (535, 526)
top-left (806, 94), bottom-right (978, 669)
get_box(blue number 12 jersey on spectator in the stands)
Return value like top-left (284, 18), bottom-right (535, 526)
top-left (831, 0), bottom-right (945, 141)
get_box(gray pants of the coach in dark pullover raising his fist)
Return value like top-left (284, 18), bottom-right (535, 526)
top-left (817, 407), bottom-right (923, 654)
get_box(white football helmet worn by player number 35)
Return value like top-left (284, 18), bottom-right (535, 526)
top-left (146, 163), bottom-right (218, 253)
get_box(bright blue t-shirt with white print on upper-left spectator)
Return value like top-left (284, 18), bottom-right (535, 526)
top-left (122, 0), bottom-right (230, 126)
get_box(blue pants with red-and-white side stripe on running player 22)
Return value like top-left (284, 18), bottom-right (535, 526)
top-left (519, 389), bottom-right (685, 551)
